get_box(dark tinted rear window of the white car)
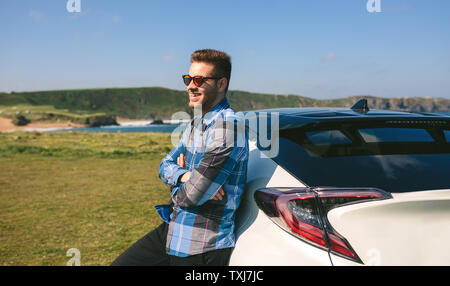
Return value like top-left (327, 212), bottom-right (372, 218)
top-left (273, 119), bottom-right (450, 193)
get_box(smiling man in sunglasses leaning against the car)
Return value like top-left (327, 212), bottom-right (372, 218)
top-left (111, 49), bottom-right (249, 266)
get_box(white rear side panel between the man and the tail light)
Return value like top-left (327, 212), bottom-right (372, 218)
top-left (230, 144), bottom-right (331, 266)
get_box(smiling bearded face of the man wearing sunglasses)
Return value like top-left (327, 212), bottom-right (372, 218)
top-left (187, 62), bottom-right (226, 113)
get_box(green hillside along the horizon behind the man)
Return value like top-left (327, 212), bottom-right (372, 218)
top-left (0, 87), bottom-right (450, 122)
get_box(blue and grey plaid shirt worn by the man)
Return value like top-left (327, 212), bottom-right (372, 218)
top-left (155, 98), bottom-right (249, 257)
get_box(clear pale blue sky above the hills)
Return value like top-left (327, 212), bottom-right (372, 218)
top-left (0, 0), bottom-right (450, 99)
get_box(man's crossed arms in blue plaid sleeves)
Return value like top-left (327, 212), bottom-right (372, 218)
top-left (159, 118), bottom-right (243, 207)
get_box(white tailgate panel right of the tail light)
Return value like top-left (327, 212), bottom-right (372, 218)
top-left (328, 190), bottom-right (450, 265)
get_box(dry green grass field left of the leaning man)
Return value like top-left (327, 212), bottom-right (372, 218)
top-left (0, 132), bottom-right (176, 265)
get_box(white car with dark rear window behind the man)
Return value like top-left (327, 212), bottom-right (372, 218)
top-left (229, 100), bottom-right (450, 266)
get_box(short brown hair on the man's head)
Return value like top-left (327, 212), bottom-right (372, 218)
top-left (191, 49), bottom-right (231, 94)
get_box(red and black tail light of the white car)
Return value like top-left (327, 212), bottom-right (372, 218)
top-left (255, 188), bottom-right (392, 263)
